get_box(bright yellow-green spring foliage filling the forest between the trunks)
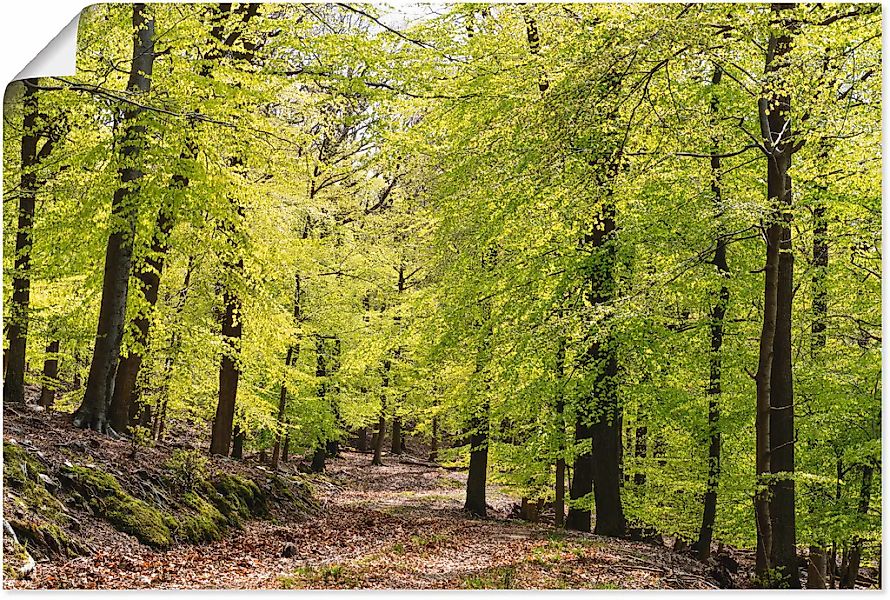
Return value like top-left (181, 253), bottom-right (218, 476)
top-left (4, 4), bottom-right (881, 564)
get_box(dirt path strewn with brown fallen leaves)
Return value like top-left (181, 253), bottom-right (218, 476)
top-left (15, 452), bottom-right (716, 589)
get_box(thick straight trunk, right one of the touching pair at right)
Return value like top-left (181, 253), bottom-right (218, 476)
top-left (761, 4), bottom-right (800, 588)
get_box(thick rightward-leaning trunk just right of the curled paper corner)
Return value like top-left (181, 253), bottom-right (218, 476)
top-left (74, 4), bottom-right (155, 432)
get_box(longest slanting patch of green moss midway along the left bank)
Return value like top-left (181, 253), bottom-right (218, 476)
top-left (62, 466), bottom-right (173, 548)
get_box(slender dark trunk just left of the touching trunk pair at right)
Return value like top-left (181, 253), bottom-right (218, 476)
top-left (696, 67), bottom-right (729, 561)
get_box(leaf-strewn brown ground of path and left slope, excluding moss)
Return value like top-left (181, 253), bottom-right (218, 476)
top-left (4, 400), bottom-right (744, 588)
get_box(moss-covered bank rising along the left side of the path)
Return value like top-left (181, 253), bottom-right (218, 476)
top-left (3, 441), bottom-right (317, 558)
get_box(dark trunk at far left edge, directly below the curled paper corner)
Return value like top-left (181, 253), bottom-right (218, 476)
top-left (3, 79), bottom-right (40, 403)
